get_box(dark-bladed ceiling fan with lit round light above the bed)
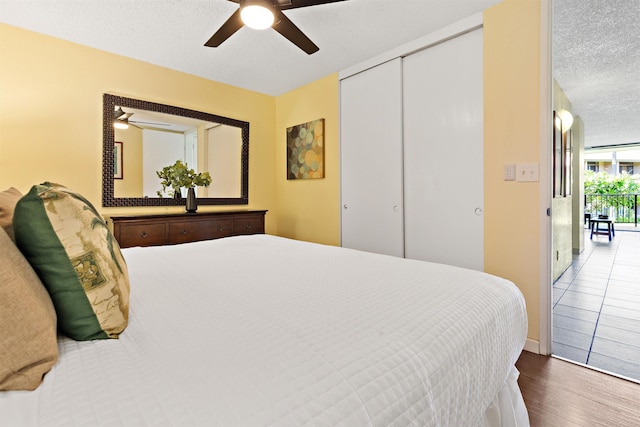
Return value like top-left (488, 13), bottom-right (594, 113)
top-left (204, 0), bottom-right (346, 55)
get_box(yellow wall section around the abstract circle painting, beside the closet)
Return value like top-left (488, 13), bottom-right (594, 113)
top-left (275, 74), bottom-right (340, 245)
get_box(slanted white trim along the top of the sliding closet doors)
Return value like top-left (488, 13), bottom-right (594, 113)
top-left (338, 12), bottom-right (482, 80)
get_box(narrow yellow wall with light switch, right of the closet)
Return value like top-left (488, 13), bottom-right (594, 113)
top-left (484, 0), bottom-right (547, 340)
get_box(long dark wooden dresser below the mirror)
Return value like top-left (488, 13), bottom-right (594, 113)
top-left (107, 211), bottom-right (267, 248)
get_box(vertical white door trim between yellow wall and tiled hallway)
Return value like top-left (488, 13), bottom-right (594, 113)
top-left (539, 0), bottom-right (553, 355)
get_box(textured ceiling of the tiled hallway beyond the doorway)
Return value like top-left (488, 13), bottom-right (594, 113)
top-left (552, 0), bottom-right (640, 146)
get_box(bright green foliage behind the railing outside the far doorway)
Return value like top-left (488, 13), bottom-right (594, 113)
top-left (584, 170), bottom-right (640, 222)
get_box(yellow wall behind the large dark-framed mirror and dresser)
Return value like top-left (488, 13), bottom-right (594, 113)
top-left (0, 24), bottom-right (276, 233)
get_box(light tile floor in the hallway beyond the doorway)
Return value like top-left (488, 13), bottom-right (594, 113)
top-left (553, 224), bottom-right (640, 382)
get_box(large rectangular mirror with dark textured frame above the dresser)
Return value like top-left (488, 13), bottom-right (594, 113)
top-left (102, 94), bottom-right (249, 207)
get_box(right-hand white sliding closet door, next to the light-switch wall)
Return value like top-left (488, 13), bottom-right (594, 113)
top-left (403, 29), bottom-right (484, 270)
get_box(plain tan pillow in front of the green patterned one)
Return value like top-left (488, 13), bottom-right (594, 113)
top-left (0, 229), bottom-right (58, 390)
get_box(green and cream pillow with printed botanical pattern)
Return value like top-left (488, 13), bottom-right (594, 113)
top-left (13, 182), bottom-right (129, 340)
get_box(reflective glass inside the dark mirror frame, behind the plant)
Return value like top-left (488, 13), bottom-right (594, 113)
top-left (113, 106), bottom-right (242, 198)
